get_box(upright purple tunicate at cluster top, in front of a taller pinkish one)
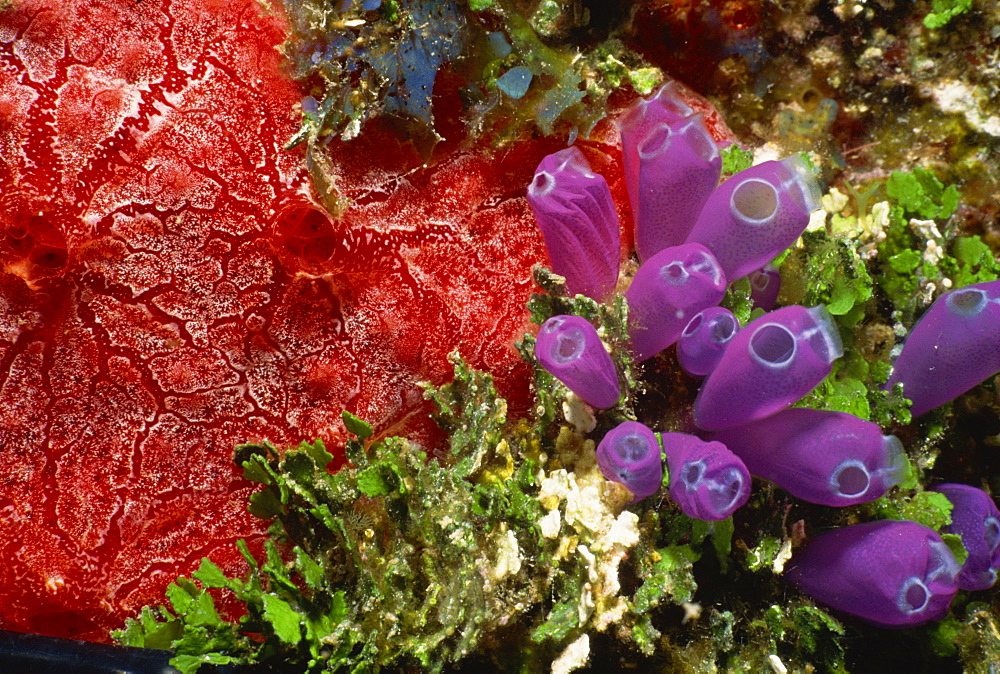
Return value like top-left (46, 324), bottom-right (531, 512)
top-left (632, 114), bottom-right (722, 261)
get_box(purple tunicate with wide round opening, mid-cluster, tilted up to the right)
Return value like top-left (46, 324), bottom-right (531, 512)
top-left (694, 306), bottom-right (843, 431)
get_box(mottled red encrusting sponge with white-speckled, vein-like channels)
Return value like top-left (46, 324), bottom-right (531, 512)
top-left (0, 0), bottom-right (560, 640)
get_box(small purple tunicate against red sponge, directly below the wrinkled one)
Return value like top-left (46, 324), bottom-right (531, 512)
top-left (535, 316), bottom-right (621, 410)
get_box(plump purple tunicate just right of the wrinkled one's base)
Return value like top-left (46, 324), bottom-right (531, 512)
top-left (625, 243), bottom-right (726, 360)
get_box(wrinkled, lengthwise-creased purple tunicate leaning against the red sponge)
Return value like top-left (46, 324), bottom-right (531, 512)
top-left (528, 147), bottom-right (621, 302)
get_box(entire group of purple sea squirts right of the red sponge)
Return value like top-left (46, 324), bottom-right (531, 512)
top-left (528, 83), bottom-right (1000, 627)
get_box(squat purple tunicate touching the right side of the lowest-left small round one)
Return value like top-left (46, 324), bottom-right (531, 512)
top-left (660, 433), bottom-right (750, 522)
